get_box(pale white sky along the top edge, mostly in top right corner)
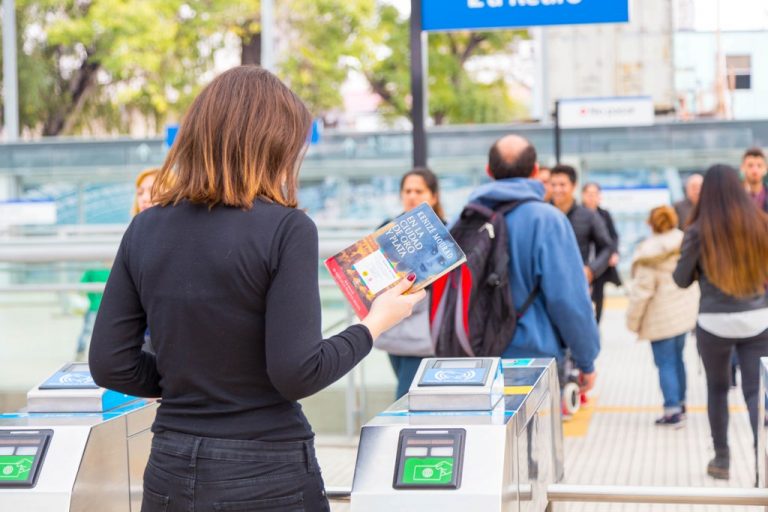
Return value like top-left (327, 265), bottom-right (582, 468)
top-left (385, 0), bottom-right (768, 30)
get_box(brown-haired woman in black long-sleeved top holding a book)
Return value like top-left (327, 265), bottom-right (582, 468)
top-left (90, 66), bottom-right (424, 512)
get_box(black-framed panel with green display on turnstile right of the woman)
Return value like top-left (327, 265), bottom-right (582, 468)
top-left (393, 428), bottom-right (467, 489)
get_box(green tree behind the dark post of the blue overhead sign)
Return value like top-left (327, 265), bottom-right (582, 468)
top-left (360, 4), bottom-right (528, 124)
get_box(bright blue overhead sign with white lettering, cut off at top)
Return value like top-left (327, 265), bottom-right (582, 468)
top-left (421, 0), bottom-right (629, 31)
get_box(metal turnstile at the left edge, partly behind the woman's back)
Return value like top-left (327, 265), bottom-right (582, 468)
top-left (0, 363), bottom-right (157, 512)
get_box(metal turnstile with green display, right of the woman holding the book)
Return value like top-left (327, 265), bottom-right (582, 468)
top-left (351, 358), bottom-right (563, 512)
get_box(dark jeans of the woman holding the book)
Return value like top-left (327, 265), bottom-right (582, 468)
top-left (141, 432), bottom-right (330, 512)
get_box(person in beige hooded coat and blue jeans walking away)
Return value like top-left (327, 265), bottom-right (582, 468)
top-left (627, 206), bottom-right (699, 427)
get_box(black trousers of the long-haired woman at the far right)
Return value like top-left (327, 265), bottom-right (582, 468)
top-left (696, 326), bottom-right (768, 449)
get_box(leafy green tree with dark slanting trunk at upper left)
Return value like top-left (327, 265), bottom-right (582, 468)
top-left (5, 0), bottom-right (212, 135)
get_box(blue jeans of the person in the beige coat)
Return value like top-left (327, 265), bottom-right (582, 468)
top-left (651, 334), bottom-right (686, 414)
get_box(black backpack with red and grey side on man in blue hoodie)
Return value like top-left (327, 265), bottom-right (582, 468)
top-left (430, 199), bottom-right (539, 357)
